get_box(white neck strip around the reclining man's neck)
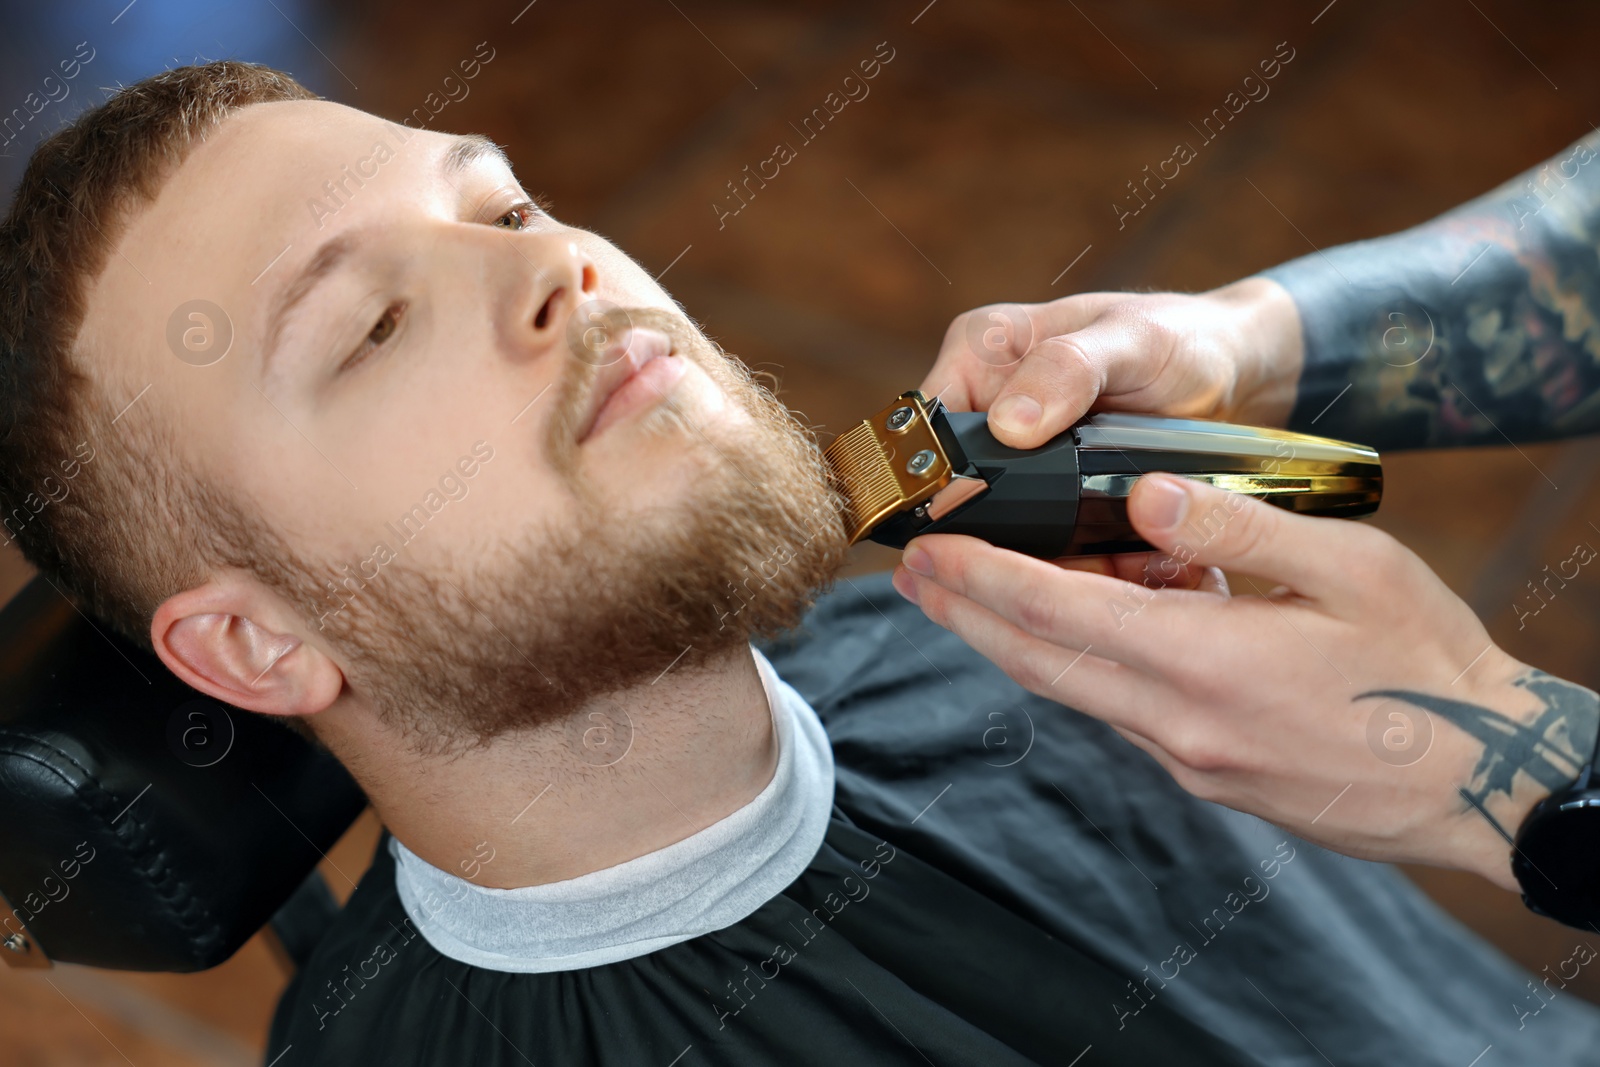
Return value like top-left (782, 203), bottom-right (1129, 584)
top-left (389, 645), bottom-right (834, 973)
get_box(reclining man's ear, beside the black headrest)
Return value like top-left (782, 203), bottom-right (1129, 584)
top-left (150, 574), bottom-right (344, 715)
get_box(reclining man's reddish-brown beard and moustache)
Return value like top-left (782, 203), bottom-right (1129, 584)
top-left (258, 309), bottom-right (850, 761)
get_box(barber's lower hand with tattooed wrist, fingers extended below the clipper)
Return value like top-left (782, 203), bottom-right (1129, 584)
top-left (894, 474), bottom-right (1600, 888)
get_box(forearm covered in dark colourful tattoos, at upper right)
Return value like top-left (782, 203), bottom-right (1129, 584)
top-left (1264, 127), bottom-right (1600, 450)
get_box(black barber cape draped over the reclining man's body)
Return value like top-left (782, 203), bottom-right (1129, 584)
top-left (267, 574), bottom-right (1600, 1067)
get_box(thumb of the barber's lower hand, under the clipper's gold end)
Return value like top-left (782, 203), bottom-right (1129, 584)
top-left (1128, 472), bottom-right (1352, 597)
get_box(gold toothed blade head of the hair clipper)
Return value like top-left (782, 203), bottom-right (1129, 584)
top-left (822, 389), bottom-right (952, 544)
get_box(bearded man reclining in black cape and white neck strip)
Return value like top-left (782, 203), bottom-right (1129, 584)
top-left (0, 62), bottom-right (1600, 1067)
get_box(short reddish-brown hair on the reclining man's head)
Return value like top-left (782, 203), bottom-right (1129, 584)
top-left (0, 61), bottom-right (317, 649)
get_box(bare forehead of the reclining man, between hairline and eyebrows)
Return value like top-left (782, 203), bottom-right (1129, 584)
top-left (77, 101), bottom-right (504, 422)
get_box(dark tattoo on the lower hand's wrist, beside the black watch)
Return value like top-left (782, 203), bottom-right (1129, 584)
top-left (1355, 669), bottom-right (1600, 835)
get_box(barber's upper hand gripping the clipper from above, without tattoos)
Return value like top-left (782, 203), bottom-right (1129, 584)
top-left (920, 278), bottom-right (1304, 448)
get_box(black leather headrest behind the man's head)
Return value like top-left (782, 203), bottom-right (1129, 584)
top-left (0, 576), bottom-right (366, 971)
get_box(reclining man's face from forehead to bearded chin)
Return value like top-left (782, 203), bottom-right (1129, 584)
top-left (78, 101), bottom-right (846, 747)
